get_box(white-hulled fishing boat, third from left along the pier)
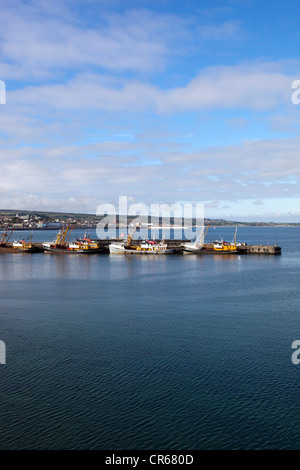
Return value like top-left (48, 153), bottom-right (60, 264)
top-left (109, 227), bottom-right (174, 255)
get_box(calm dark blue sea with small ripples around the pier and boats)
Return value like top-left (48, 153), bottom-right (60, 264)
top-left (0, 227), bottom-right (300, 450)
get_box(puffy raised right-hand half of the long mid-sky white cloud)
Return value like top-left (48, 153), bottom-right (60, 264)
top-left (157, 62), bottom-right (300, 112)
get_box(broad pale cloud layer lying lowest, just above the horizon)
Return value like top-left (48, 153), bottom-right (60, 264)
top-left (0, 134), bottom-right (300, 215)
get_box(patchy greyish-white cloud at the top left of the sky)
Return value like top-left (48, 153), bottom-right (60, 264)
top-left (0, 4), bottom-right (168, 80)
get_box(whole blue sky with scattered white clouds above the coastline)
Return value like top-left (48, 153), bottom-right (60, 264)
top-left (0, 0), bottom-right (300, 222)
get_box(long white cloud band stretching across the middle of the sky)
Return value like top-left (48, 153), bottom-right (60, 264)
top-left (7, 62), bottom-right (300, 113)
